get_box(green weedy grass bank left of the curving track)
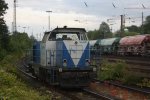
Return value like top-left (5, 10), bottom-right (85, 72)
top-left (0, 55), bottom-right (52, 100)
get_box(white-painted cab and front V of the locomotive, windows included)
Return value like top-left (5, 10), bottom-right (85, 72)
top-left (41, 27), bottom-right (88, 66)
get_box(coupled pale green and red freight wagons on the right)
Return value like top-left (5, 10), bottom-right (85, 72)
top-left (89, 34), bottom-right (150, 56)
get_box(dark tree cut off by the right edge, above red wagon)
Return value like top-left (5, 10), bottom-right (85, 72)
top-left (143, 16), bottom-right (150, 34)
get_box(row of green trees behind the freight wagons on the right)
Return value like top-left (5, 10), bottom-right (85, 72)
top-left (88, 16), bottom-right (150, 40)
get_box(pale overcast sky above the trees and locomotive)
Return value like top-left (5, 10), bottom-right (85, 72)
top-left (5, 0), bottom-right (150, 39)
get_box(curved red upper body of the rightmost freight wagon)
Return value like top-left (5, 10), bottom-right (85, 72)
top-left (119, 35), bottom-right (150, 46)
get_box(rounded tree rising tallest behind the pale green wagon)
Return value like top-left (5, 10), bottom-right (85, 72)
top-left (99, 22), bottom-right (112, 38)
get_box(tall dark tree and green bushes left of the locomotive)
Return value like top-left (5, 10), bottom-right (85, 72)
top-left (0, 0), bottom-right (34, 61)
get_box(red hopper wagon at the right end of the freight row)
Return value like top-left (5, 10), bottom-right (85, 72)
top-left (118, 35), bottom-right (150, 56)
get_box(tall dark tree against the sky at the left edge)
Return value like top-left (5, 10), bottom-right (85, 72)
top-left (0, 0), bottom-right (9, 49)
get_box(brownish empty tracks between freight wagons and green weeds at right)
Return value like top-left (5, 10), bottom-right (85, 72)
top-left (101, 56), bottom-right (150, 78)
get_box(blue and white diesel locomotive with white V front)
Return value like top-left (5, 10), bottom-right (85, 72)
top-left (31, 27), bottom-right (96, 87)
